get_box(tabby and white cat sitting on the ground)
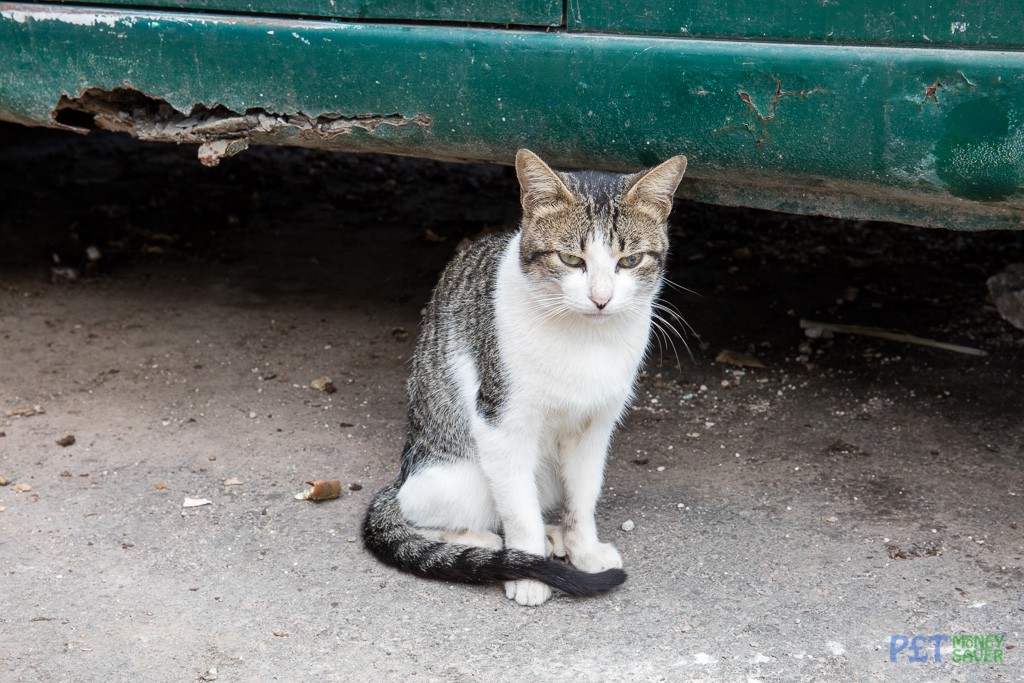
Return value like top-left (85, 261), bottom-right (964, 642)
top-left (362, 150), bottom-right (686, 605)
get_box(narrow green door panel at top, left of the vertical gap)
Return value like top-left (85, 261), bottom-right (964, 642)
top-left (46, 0), bottom-right (562, 27)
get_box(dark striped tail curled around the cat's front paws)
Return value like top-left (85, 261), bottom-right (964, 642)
top-left (362, 482), bottom-right (626, 597)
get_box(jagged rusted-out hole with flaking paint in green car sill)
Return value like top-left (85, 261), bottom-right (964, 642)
top-left (52, 86), bottom-right (432, 166)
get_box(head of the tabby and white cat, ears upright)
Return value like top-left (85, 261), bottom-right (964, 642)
top-left (515, 150), bottom-right (686, 318)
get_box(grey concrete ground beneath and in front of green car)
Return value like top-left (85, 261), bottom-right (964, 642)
top-left (0, 126), bottom-right (1024, 682)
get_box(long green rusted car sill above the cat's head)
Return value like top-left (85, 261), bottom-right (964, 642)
top-left (0, 3), bottom-right (1024, 229)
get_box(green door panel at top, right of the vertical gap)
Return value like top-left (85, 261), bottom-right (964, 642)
top-left (567, 0), bottom-right (1024, 47)
